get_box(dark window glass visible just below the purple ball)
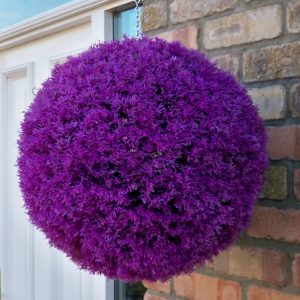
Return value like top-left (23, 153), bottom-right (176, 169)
top-left (114, 281), bottom-right (146, 300)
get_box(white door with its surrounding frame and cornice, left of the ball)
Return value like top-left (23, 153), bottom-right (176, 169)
top-left (0, 0), bottom-right (135, 300)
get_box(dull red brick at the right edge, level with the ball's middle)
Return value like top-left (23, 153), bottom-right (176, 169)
top-left (267, 126), bottom-right (300, 160)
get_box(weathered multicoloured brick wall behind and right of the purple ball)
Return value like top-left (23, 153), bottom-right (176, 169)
top-left (142, 0), bottom-right (300, 300)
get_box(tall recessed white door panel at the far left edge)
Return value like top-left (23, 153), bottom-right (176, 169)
top-left (1, 68), bottom-right (33, 299)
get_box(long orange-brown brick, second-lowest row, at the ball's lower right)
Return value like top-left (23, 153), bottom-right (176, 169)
top-left (206, 247), bottom-right (287, 286)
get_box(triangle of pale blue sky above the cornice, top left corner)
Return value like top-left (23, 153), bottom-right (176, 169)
top-left (0, 0), bottom-right (72, 30)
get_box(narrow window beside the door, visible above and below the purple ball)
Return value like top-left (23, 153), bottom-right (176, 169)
top-left (113, 4), bottom-right (146, 300)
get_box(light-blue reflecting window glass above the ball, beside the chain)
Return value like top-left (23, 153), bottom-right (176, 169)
top-left (114, 7), bottom-right (142, 40)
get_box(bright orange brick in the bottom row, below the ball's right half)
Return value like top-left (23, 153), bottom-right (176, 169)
top-left (174, 273), bottom-right (241, 300)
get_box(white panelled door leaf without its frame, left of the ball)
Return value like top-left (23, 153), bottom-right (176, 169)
top-left (1, 63), bottom-right (105, 300)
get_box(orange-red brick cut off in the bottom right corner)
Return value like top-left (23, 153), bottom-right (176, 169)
top-left (247, 285), bottom-right (300, 300)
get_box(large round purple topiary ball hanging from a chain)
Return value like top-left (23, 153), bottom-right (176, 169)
top-left (18, 37), bottom-right (267, 281)
